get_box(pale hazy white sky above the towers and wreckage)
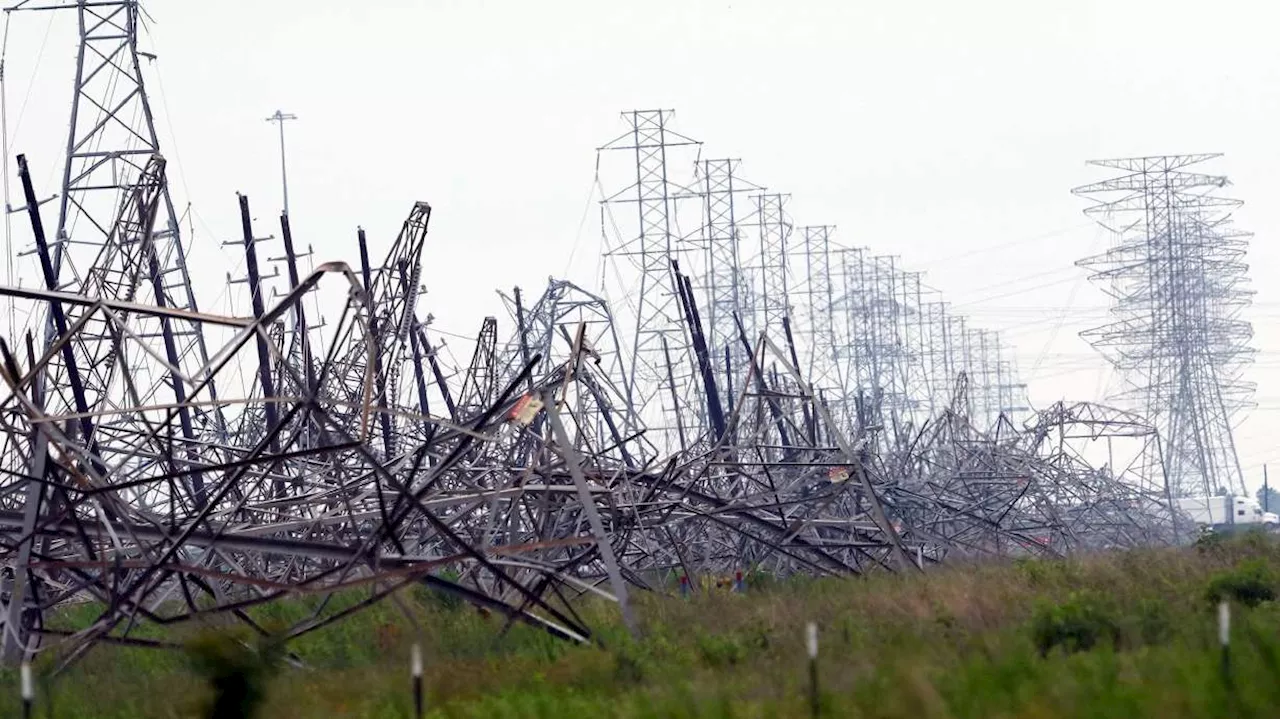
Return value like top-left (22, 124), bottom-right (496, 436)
top-left (5, 0), bottom-right (1280, 484)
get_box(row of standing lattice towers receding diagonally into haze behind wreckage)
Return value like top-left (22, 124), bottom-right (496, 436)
top-left (602, 110), bottom-right (1025, 441)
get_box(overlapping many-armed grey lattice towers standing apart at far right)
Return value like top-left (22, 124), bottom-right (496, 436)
top-left (1073, 155), bottom-right (1253, 496)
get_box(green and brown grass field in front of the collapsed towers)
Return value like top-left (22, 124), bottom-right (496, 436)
top-left (0, 536), bottom-right (1280, 719)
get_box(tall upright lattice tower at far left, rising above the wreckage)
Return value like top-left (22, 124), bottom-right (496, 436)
top-left (38, 0), bottom-right (225, 443)
